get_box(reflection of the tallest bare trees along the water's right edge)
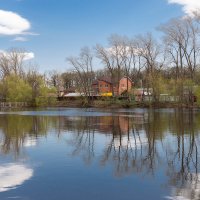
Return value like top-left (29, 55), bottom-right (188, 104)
top-left (166, 111), bottom-right (200, 200)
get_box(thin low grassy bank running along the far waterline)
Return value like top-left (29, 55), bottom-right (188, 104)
top-left (0, 99), bottom-right (199, 109)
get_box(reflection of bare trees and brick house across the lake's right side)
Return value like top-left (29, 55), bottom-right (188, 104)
top-left (65, 110), bottom-right (200, 199)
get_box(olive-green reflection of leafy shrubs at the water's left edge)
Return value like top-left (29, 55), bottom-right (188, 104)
top-left (0, 115), bottom-right (58, 158)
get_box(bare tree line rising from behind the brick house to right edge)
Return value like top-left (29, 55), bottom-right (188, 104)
top-left (64, 13), bottom-right (200, 103)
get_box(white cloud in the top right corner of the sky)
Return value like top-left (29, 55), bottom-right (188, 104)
top-left (168, 0), bottom-right (200, 15)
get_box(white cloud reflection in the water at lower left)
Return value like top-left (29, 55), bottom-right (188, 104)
top-left (0, 164), bottom-right (33, 192)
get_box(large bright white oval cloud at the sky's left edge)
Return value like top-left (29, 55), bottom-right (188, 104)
top-left (0, 10), bottom-right (31, 35)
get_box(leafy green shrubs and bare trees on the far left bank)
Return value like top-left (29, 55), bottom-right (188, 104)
top-left (0, 49), bottom-right (55, 106)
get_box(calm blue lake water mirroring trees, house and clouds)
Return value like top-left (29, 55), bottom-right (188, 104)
top-left (0, 108), bottom-right (200, 200)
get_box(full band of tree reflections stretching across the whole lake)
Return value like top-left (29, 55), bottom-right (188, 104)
top-left (0, 110), bottom-right (200, 199)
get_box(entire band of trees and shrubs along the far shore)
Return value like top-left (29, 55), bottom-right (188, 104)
top-left (0, 13), bottom-right (200, 106)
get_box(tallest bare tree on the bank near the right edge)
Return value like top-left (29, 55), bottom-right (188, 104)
top-left (160, 17), bottom-right (200, 103)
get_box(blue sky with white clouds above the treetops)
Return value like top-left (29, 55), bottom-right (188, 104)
top-left (0, 0), bottom-right (200, 72)
